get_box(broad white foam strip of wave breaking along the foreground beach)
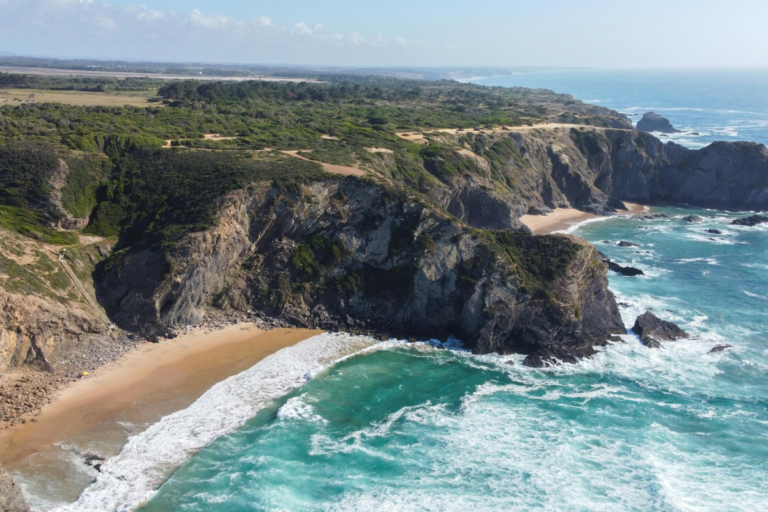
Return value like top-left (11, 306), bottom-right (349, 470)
top-left (57, 333), bottom-right (384, 512)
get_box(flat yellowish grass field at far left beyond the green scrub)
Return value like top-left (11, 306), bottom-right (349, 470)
top-left (0, 89), bottom-right (161, 107)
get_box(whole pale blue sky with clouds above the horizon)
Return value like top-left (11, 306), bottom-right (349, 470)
top-left (0, 0), bottom-right (768, 68)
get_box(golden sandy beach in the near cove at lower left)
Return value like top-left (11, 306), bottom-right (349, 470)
top-left (0, 323), bottom-right (322, 470)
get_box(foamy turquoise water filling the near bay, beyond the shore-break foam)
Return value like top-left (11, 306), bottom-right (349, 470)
top-left (143, 208), bottom-right (768, 512)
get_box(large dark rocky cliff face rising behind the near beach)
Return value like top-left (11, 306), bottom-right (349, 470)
top-left (98, 179), bottom-right (625, 359)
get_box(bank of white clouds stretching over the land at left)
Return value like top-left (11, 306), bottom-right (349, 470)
top-left (0, 0), bottom-right (420, 64)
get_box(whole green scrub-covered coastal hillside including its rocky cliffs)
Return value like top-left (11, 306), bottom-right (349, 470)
top-left (0, 75), bottom-right (768, 426)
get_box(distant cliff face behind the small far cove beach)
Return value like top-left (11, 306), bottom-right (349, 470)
top-left (412, 127), bottom-right (768, 217)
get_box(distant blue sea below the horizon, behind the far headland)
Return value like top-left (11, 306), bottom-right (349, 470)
top-left (475, 69), bottom-right (768, 149)
